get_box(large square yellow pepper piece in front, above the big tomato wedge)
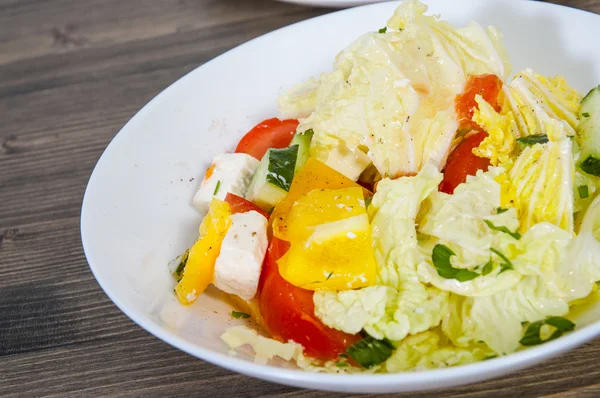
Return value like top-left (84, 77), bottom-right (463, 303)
top-left (277, 187), bottom-right (377, 290)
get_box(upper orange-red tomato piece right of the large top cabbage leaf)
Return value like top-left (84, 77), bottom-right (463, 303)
top-left (455, 74), bottom-right (502, 130)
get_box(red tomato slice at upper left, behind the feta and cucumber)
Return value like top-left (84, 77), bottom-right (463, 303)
top-left (235, 118), bottom-right (299, 160)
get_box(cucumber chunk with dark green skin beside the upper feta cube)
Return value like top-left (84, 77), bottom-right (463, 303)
top-left (246, 145), bottom-right (299, 211)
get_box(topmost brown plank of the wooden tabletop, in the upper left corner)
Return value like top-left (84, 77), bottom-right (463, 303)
top-left (0, 0), bottom-right (325, 64)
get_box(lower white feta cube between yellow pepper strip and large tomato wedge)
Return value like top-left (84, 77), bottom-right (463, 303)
top-left (213, 211), bottom-right (268, 300)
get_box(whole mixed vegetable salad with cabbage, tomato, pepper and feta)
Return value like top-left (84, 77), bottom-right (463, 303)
top-left (171, 0), bottom-right (600, 373)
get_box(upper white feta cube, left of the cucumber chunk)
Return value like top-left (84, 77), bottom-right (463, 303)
top-left (192, 153), bottom-right (260, 213)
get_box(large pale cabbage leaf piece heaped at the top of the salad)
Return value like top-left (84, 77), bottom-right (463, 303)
top-left (279, 0), bottom-right (510, 177)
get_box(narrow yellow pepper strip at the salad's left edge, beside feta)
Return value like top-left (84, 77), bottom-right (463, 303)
top-left (175, 199), bottom-right (231, 305)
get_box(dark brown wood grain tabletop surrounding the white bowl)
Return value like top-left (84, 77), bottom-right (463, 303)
top-left (0, 0), bottom-right (600, 397)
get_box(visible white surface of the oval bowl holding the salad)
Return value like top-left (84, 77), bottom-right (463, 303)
top-left (81, 0), bottom-right (600, 393)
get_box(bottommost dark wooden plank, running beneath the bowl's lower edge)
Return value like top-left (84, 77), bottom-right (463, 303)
top-left (0, 329), bottom-right (600, 398)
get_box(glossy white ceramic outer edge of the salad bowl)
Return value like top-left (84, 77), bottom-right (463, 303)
top-left (80, 3), bottom-right (600, 393)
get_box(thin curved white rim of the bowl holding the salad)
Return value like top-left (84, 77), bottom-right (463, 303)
top-left (80, 0), bottom-right (600, 392)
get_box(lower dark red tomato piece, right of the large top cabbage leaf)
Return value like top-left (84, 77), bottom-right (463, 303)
top-left (439, 131), bottom-right (490, 194)
